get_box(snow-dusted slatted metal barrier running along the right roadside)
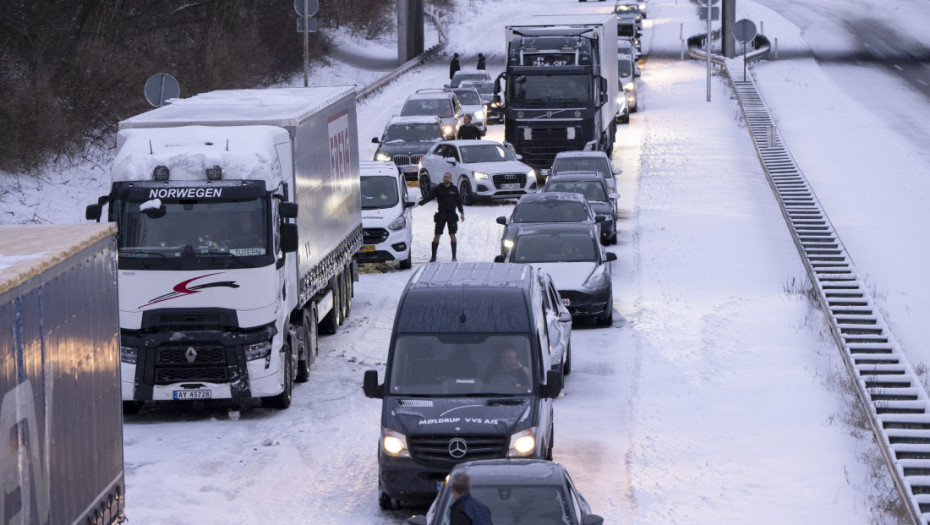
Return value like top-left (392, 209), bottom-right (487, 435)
top-left (715, 61), bottom-right (930, 525)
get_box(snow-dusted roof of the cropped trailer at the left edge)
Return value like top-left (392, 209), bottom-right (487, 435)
top-left (0, 224), bottom-right (116, 295)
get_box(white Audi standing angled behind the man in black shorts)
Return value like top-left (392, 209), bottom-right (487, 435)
top-left (420, 140), bottom-right (537, 205)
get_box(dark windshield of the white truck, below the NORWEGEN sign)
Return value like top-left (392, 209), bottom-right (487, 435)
top-left (114, 198), bottom-right (272, 267)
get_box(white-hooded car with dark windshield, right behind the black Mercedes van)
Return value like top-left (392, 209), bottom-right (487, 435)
top-left (494, 222), bottom-right (617, 325)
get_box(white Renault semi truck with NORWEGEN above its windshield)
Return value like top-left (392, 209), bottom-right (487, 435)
top-left (87, 87), bottom-right (362, 412)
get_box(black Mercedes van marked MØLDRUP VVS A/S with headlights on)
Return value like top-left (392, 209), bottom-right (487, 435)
top-left (364, 263), bottom-right (562, 509)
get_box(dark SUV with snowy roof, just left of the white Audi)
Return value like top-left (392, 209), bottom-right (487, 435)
top-left (371, 115), bottom-right (445, 180)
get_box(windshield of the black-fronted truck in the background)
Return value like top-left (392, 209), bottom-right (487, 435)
top-left (507, 75), bottom-right (592, 107)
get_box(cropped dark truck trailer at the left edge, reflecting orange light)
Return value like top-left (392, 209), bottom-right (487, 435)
top-left (0, 224), bottom-right (126, 525)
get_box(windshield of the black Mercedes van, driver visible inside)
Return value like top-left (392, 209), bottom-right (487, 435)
top-left (387, 334), bottom-right (539, 397)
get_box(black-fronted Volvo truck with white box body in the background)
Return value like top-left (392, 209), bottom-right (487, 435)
top-left (496, 13), bottom-right (620, 171)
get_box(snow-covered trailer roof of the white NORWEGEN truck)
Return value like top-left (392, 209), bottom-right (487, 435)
top-left (119, 86), bottom-right (355, 129)
